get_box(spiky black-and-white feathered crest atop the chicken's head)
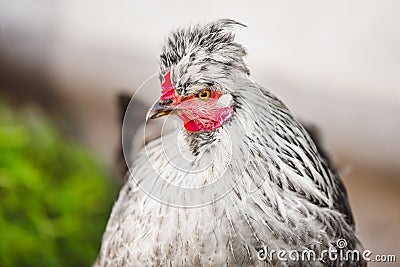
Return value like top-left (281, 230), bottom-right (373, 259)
top-left (160, 19), bottom-right (249, 75)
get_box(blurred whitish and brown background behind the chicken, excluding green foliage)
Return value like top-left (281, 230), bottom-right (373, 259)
top-left (0, 0), bottom-right (400, 266)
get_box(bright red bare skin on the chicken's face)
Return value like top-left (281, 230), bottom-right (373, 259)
top-left (160, 71), bottom-right (233, 132)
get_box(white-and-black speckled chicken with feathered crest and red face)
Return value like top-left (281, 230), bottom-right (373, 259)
top-left (95, 19), bottom-right (365, 266)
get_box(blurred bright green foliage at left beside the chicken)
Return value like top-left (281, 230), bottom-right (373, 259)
top-left (0, 104), bottom-right (117, 267)
